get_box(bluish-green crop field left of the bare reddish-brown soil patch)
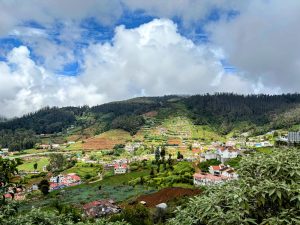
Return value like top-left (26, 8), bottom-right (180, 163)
top-left (22, 170), bottom-right (155, 210)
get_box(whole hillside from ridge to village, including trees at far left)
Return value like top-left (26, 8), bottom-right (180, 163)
top-left (0, 93), bottom-right (300, 150)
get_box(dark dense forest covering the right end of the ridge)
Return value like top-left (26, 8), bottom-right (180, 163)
top-left (184, 93), bottom-right (300, 133)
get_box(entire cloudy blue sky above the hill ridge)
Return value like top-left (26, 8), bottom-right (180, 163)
top-left (0, 0), bottom-right (300, 117)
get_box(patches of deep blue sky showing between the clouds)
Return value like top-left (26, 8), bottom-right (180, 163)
top-left (0, 9), bottom-right (223, 76)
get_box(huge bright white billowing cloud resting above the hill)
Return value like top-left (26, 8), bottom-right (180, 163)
top-left (0, 19), bottom-right (252, 116)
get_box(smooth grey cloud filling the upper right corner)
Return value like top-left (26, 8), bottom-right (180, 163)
top-left (207, 0), bottom-right (300, 93)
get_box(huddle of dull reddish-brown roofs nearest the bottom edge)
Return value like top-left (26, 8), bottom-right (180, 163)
top-left (83, 200), bottom-right (121, 218)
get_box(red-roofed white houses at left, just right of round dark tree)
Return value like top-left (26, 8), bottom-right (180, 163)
top-left (50, 173), bottom-right (81, 191)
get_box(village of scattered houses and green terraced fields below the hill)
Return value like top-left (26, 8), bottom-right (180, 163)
top-left (0, 114), bottom-right (300, 217)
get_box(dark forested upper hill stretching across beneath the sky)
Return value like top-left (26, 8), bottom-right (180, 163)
top-left (0, 93), bottom-right (300, 140)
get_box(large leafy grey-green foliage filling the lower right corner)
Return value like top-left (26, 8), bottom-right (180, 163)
top-left (169, 149), bottom-right (300, 225)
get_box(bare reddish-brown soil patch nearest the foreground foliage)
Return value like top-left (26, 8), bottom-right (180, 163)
top-left (137, 187), bottom-right (201, 207)
